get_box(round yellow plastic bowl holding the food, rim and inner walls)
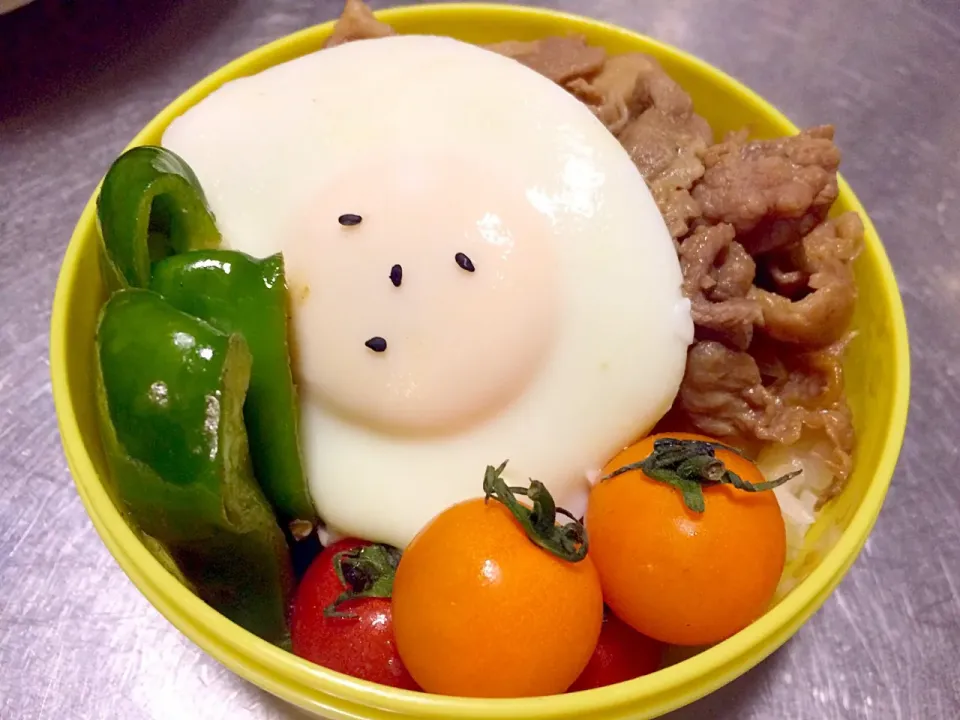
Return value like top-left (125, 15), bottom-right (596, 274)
top-left (50, 4), bottom-right (909, 720)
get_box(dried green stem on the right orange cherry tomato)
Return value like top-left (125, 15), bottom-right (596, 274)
top-left (600, 438), bottom-right (802, 513)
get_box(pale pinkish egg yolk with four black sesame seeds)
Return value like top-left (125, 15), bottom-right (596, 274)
top-left (284, 149), bottom-right (560, 434)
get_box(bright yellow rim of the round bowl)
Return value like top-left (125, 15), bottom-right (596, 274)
top-left (50, 3), bottom-right (910, 720)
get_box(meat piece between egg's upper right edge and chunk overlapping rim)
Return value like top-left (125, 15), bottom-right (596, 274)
top-left (620, 107), bottom-right (713, 238)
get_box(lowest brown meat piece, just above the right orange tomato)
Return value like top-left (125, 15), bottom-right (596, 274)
top-left (677, 341), bottom-right (854, 487)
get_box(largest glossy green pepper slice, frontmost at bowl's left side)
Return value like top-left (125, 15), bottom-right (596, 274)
top-left (96, 290), bottom-right (293, 644)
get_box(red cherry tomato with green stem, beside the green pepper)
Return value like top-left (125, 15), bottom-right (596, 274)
top-left (290, 538), bottom-right (419, 690)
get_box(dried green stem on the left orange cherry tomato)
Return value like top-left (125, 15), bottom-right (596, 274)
top-left (483, 460), bottom-right (587, 562)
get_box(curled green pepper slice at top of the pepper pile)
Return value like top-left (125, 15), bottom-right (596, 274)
top-left (97, 145), bottom-right (220, 291)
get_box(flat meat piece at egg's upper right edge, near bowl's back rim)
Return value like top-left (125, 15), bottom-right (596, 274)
top-left (484, 35), bottom-right (607, 85)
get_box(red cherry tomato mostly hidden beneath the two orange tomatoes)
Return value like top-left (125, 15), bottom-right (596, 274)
top-left (567, 610), bottom-right (664, 692)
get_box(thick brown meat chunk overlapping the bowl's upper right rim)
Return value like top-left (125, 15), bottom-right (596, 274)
top-left (693, 126), bottom-right (840, 256)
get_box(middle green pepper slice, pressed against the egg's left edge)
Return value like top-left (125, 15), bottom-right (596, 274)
top-left (150, 250), bottom-right (317, 540)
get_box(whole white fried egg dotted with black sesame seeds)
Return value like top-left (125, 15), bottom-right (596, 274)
top-left (163, 36), bottom-right (693, 548)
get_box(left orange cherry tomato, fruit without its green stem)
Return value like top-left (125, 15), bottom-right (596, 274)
top-left (393, 466), bottom-right (603, 698)
